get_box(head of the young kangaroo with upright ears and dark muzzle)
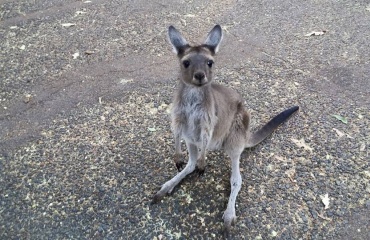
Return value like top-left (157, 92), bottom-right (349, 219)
top-left (168, 25), bottom-right (222, 87)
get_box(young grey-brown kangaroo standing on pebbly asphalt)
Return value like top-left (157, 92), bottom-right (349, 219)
top-left (152, 25), bottom-right (299, 236)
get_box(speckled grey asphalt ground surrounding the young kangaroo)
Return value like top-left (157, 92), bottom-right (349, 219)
top-left (0, 0), bottom-right (370, 239)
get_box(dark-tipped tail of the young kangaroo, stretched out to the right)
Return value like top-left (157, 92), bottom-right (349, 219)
top-left (246, 106), bottom-right (299, 148)
